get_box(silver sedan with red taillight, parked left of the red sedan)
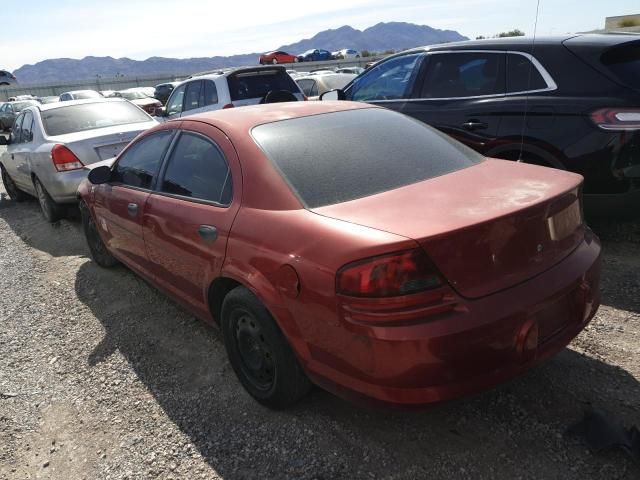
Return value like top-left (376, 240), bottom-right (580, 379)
top-left (0, 97), bottom-right (158, 222)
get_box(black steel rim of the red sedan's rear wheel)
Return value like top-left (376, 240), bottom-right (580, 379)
top-left (232, 310), bottom-right (276, 391)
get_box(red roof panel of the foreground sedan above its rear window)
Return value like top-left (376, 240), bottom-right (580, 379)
top-left (168, 101), bottom-right (381, 135)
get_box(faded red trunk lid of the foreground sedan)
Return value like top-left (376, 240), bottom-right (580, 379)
top-left (313, 160), bottom-right (585, 298)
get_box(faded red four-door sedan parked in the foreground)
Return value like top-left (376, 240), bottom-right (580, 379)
top-left (79, 102), bottom-right (600, 407)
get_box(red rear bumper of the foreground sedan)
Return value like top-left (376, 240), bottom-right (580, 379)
top-left (302, 232), bottom-right (600, 406)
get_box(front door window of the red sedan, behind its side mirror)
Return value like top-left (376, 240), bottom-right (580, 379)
top-left (111, 130), bottom-right (174, 190)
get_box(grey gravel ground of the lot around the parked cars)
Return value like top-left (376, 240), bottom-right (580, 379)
top-left (0, 164), bottom-right (640, 480)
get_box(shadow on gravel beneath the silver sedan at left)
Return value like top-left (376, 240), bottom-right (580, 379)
top-left (0, 193), bottom-right (89, 257)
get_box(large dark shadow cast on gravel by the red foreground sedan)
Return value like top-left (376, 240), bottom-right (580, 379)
top-left (75, 262), bottom-right (640, 479)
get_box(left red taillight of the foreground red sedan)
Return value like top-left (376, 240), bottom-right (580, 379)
top-left (336, 249), bottom-right (443, 297)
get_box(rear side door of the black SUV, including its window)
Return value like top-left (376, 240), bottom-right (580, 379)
top-left (403, 51), bottom-right (506, 153)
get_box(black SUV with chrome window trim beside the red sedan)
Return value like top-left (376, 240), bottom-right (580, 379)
top-left (323, 34), bottom-right (640, 215)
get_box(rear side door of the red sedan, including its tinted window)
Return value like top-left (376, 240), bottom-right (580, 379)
top-left (143, 121), bottom-right (241, 315)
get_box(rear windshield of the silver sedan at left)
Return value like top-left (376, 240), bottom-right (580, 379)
top-left (42, 102), bottom-right (150, 137)
